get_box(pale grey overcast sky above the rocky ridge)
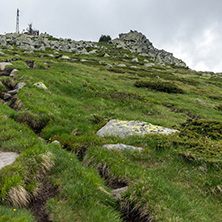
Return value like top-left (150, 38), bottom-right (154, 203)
top-left (0, 0), bottom-right (222, 72)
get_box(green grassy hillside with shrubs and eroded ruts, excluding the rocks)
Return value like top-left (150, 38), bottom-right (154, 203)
top-left (0, 40), bottom-right (222, 222)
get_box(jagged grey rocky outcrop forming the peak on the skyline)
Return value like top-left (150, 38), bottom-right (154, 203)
top-left (112, 31), bottom-right (186, 67)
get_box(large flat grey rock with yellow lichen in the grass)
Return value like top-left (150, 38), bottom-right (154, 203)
top-left (96, 120), bottom-right (179, 137)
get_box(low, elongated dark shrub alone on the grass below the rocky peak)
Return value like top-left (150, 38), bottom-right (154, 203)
top-left (134, 81), bottom-right (184, 93)
